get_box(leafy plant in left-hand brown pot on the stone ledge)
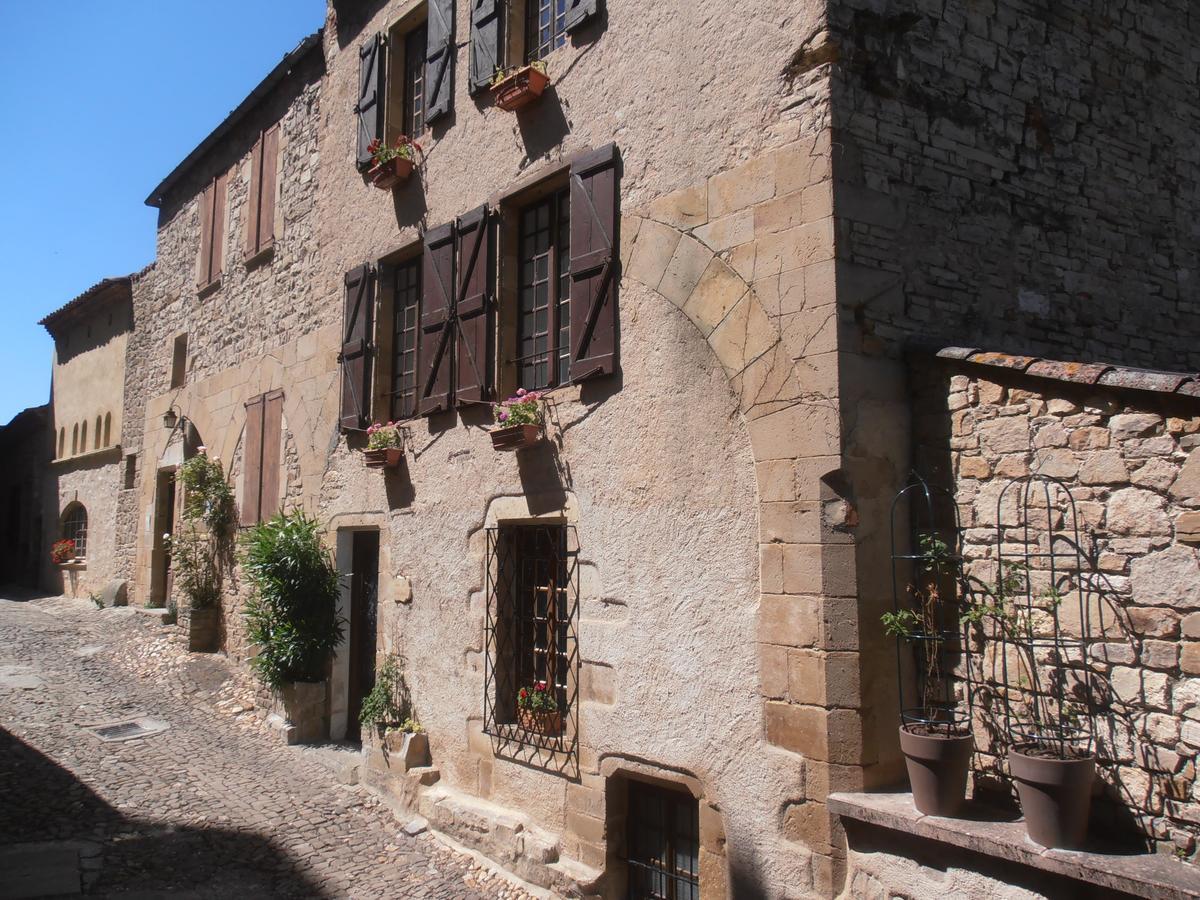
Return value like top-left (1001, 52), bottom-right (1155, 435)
top-left (881, 533), bottom-right (974, 816)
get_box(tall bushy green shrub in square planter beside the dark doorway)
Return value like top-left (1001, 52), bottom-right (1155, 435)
top-left (241, 510), bottom-right (344, 742)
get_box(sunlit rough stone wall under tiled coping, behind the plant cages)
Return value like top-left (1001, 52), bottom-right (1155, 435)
top-left (912, 361), bottom-right (1200, 853)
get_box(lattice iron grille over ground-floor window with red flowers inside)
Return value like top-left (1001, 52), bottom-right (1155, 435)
top-left (484, 523), bottom-right (580, 770)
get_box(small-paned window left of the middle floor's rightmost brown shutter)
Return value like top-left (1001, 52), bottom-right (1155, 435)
top-left (516, 188), bottom-right (571, 390)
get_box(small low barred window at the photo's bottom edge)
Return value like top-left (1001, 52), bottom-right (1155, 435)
top-left (625, 781), bottom-right (700, 900)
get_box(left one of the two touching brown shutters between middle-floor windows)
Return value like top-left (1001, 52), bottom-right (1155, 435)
top-left (416, 222), bottom-right (455, 415)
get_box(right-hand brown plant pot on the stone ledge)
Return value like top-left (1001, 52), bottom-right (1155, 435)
top-left (1008, 745), bottom-right (1096, 850)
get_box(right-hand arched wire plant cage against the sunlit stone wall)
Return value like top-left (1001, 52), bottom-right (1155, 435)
top-left (994, 475), bottom-right (1096, 758)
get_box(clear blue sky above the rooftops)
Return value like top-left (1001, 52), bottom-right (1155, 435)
top-left (0, 0), bottom-right (325, 425)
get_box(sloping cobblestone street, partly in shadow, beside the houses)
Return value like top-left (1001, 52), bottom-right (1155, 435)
top-left (0, 599), bottom-right (528, 899)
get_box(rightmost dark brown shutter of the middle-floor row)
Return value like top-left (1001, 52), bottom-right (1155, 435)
top-left (571, 144), bottom-right (619, 382)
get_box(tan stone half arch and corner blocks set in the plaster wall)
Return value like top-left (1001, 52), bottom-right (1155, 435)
top-left (620, 210), bottom-right (866, 884)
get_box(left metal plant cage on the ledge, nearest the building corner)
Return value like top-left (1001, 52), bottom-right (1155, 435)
top-left (890, 472), bottom-right (973, 736)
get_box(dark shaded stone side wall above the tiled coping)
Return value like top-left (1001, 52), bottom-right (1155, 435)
top-left (825, 0), bottom-right (1200, 368)
